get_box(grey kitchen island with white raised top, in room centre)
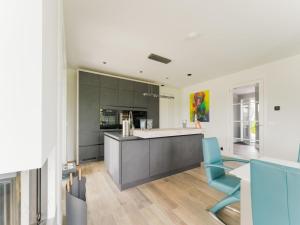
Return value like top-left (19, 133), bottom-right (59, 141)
top-left (104, 129), bottom-right (203, 190)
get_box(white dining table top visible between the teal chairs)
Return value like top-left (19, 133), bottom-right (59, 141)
top-left (229, 157), bottom-right (300, 182)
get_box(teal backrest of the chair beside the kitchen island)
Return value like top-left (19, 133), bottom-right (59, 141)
top-left (202, 137), bottom-right (225, 183)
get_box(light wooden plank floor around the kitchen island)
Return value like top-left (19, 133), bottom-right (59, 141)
top-left (64, 162), bottom-right (240, 225)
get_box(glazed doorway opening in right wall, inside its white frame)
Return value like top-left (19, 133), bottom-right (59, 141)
top-left (233, 83), bottom-right (261, 158)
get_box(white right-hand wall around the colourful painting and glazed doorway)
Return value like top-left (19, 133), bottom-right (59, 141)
top-left (181, 55), bottom-right (300, 160)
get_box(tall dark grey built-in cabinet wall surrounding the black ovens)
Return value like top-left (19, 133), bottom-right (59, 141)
top-left (78, 70), bottom-right (159, 162)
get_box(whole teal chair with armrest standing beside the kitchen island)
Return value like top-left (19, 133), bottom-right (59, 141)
top-left (202, 137), bottom-right (249, 220)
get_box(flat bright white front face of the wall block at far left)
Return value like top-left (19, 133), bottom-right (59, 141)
top-left (0, 0), bottom-right (42, 173)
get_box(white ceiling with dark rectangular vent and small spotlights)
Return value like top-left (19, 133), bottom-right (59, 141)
top-left (64, 0), bottom-right (300, 87)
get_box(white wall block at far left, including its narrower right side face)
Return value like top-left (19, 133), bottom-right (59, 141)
top-left (0, 0), bottom-right (65, 225)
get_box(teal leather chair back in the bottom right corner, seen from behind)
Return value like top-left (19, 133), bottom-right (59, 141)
top-left (250, 160), bottom-right (300, 225)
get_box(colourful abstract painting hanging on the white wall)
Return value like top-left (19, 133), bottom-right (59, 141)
top-left (190, 90), bottom-right (209, 122)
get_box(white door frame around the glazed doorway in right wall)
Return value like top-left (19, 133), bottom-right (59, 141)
top-left (227, 79), bottom-right (265, 156)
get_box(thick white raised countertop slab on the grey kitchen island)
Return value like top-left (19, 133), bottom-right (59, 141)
top-left (133, 128), bottom-right (203, 138)
